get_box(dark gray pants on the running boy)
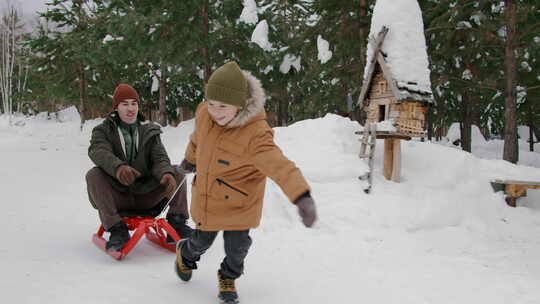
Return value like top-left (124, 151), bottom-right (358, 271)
top-left (180, 229), bottom-right (252, 279)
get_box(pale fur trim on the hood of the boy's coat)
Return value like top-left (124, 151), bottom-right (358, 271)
top-left (225, 70), bottom-right (266, 128)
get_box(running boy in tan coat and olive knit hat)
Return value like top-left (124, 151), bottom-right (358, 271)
top-left (175, 62), bottom-right (317, 303)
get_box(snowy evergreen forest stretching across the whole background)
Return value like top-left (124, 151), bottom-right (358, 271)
top-left (0, 0), bottom-right (540, 163)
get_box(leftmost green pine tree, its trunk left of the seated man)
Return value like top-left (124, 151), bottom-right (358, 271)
top-left (28, 0), bottom-right (109, 128)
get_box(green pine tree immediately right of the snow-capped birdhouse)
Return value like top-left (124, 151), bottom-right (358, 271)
top-left (424, 0), bottom-right (501, 151)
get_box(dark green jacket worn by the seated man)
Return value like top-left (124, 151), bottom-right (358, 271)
top-left (88, 112), bottom-right (174, 194)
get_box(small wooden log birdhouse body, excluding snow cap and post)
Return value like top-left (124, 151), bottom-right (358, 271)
top-left (358, 27), bottom-right (433, 137)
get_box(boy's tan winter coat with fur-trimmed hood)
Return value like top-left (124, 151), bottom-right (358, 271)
top-left (185, 71), bottom-right (309, 231)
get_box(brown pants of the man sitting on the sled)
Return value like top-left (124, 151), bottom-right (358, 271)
top-left (86, 167), bottom-right (189, 231)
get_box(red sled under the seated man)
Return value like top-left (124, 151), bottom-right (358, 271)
top-left (92, 216), bottom-right (180, 260)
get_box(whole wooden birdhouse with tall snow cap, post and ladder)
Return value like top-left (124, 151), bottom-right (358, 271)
top-left (355, 0), bottom-right (434, 188)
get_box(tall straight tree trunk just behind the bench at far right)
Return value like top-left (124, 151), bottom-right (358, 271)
top-left (503, 0), bottom-right (519, 164)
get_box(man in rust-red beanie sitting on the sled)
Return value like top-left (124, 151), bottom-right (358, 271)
top-left (86, 84), bottom-right (192, 251)
